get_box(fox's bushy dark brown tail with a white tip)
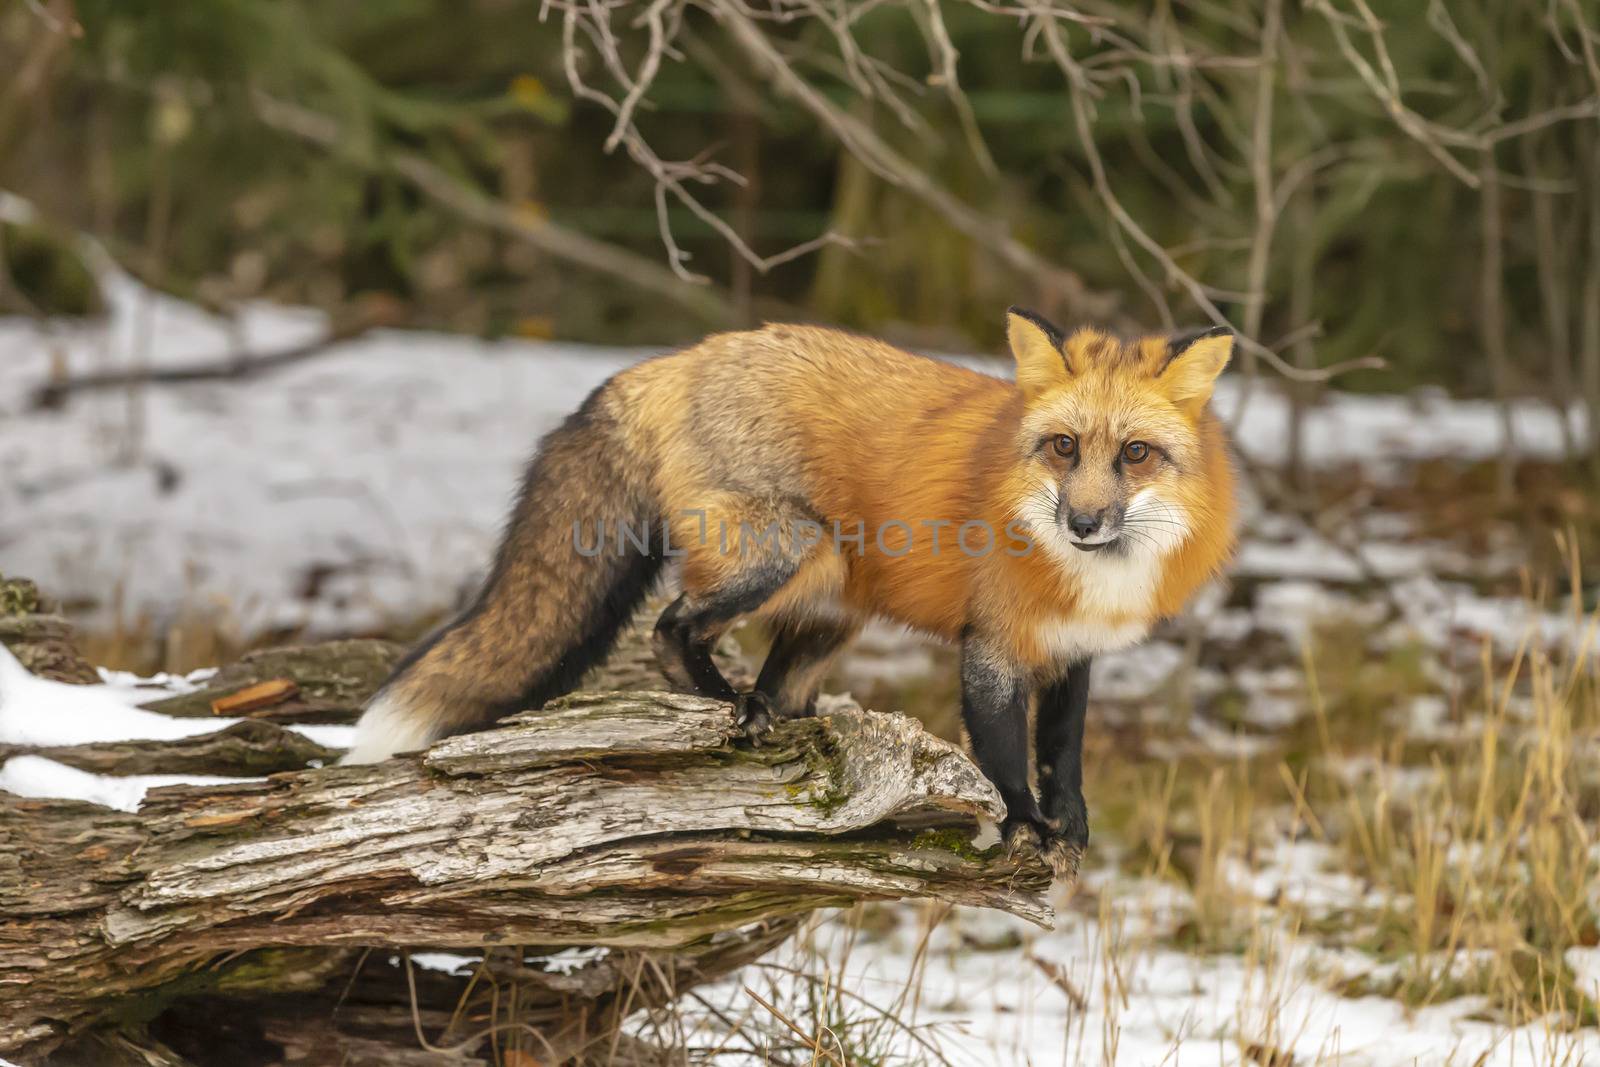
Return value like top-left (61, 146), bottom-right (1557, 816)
top-left (344, 386), bottom-right (664, 763)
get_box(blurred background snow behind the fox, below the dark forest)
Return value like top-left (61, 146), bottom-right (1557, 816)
top-left (0, 268), bottom-right (1580, 632)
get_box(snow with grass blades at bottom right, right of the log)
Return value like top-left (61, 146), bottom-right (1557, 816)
top-left (725, 902), bottom-right (1600, 1067)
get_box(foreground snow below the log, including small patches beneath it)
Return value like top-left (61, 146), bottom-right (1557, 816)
top-left (389, 895), bottom-right (1600, 1067)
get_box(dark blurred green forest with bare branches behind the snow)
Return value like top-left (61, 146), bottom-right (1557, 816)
top-left (0, 0), bottom-right (1600, 405)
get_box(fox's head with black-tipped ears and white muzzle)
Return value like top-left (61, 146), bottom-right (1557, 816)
top-left (1006, 307), bottom-right (1234, 558)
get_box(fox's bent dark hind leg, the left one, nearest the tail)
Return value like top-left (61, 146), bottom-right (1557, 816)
top-left (654, 566), bottom-right (794, 737)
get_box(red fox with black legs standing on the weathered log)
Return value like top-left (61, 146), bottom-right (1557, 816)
top-left (347, 309), bottom-right (1235, 862)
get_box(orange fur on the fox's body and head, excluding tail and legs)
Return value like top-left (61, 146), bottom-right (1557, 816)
top-left (618, 322), bottom-right (1234, 670)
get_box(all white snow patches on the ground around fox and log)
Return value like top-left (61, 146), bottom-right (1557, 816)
top-left (0, 273), bottom-right (1600, 1067)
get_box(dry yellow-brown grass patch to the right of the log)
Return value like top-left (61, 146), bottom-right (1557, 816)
top-left (1090, 572), bottom-right (1600, 1029)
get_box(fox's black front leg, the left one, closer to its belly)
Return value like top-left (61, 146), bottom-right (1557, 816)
top-left (962, 637), bottom-right (1051, 845)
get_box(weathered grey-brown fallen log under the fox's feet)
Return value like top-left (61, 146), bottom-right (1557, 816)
top-left (0, 604), bottom-right (1050, 1064)
